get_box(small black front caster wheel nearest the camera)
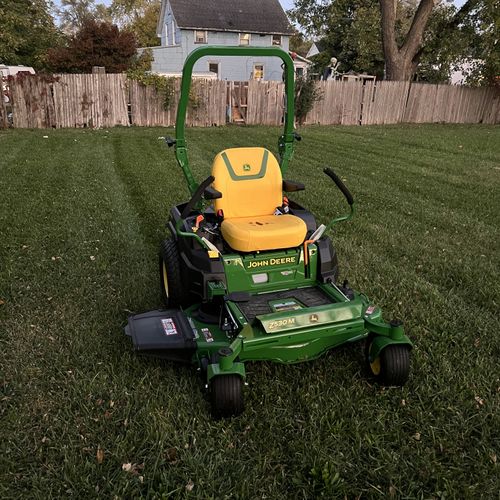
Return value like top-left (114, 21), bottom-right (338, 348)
top-left (210, 375), bottom-right (244, 418)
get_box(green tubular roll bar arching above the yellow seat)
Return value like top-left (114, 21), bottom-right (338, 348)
top-left (175, 46), bottom-right (295, 194)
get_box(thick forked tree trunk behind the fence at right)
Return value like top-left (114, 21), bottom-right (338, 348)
top-left (379, 0), bottom-right (438, 81)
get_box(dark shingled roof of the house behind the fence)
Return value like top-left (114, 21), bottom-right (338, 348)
top-left (161, 0), bottom-right (293, 35)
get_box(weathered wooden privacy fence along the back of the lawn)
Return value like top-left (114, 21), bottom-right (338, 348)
top-left (0, 74), bottom-right (500, 128)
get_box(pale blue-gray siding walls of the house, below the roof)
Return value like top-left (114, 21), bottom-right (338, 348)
top-left (151, 29), bottom-right (289, 81)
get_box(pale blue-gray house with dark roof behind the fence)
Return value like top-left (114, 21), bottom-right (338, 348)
top-left (151, 0), bottom-right (293, 81)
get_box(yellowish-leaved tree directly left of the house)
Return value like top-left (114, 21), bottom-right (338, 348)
top-left (110, 0), bottom-right (161, 47)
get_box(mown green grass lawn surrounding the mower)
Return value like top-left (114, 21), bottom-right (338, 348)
top-left (0, 125), bottom-right (500, 499)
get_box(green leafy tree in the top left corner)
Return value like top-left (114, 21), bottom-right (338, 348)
top-left (0, 0), bottom-right (59, 69)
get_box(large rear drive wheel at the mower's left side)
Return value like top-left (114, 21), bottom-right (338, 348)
top-left (160, 238), bottom-right (189, 307)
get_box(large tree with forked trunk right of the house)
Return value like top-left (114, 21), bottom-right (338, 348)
top-left (290, 0), bottom-right (486, 81)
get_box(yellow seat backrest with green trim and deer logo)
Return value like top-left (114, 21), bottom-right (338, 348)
top-left (212, 148), bottom-right (283, 219)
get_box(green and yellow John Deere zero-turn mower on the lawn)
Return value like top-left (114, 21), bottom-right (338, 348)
top-left (125, 47), bottom-right (411, 417)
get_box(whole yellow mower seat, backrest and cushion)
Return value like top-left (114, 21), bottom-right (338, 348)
top-left (212, 148), bottom-right (307, 252)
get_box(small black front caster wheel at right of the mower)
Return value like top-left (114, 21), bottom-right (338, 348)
top-left (366, 343), bottom-right (410, 386)
